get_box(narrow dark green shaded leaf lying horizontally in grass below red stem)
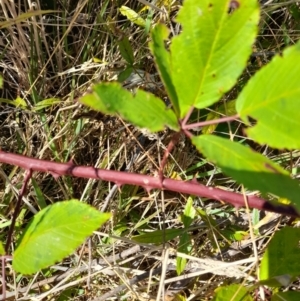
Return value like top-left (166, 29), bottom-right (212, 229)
top-left (132, 229), bottom-right (185, 245)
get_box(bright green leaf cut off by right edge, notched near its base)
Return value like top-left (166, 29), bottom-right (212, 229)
top-left (236, 42), bottom-right (300, 149)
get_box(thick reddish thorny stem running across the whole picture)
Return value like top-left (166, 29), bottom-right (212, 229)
top-left (0, 151), bottom-right (299, 217)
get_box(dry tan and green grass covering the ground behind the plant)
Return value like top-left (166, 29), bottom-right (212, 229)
top-left (0, 0), bottom-right (300, 301)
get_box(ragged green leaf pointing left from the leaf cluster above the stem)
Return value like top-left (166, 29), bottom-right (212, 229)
top-left (80, 83), bottom-right (179, 132)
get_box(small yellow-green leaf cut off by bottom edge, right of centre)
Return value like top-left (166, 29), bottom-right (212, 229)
top-left (213, 284), bottom-right (253, 301)
